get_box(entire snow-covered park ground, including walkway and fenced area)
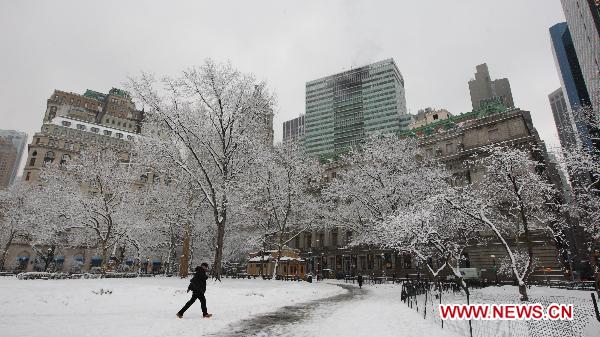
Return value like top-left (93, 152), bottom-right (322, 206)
top-left (0, 277), bottom-right (600, 337)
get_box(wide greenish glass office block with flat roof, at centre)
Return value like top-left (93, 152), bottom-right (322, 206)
top-left (304, 59), bottom-right (410, 156)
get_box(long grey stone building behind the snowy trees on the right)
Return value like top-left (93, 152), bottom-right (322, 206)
top-left (292, 108), bottom-right (564, 280)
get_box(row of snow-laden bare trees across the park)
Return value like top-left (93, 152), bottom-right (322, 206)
top-left (0, 61), bottom-right (599, 300)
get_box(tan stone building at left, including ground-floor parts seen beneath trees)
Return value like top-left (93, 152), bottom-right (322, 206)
top-left (5, 88), bottom-right (152, 271)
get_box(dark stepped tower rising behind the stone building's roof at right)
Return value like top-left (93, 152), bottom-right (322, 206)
top-left (469, 63), bottom-right (515, 110)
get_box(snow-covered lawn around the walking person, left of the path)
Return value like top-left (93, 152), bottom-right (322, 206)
top-left (0, 277), bottom-right (345, 337)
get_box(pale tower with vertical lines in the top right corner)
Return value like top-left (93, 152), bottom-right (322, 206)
top-left (561, 0), bottom-right (600, 109)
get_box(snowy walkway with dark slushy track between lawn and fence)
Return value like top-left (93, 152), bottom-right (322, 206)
top-left (213, 284), bottom-right (455, 337)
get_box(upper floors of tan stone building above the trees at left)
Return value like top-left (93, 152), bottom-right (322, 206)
top-left (23, 88), bottom-right (144, 181)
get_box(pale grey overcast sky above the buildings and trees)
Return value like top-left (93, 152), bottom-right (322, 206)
top-left (0, 0), bottom-right (564, 169)
